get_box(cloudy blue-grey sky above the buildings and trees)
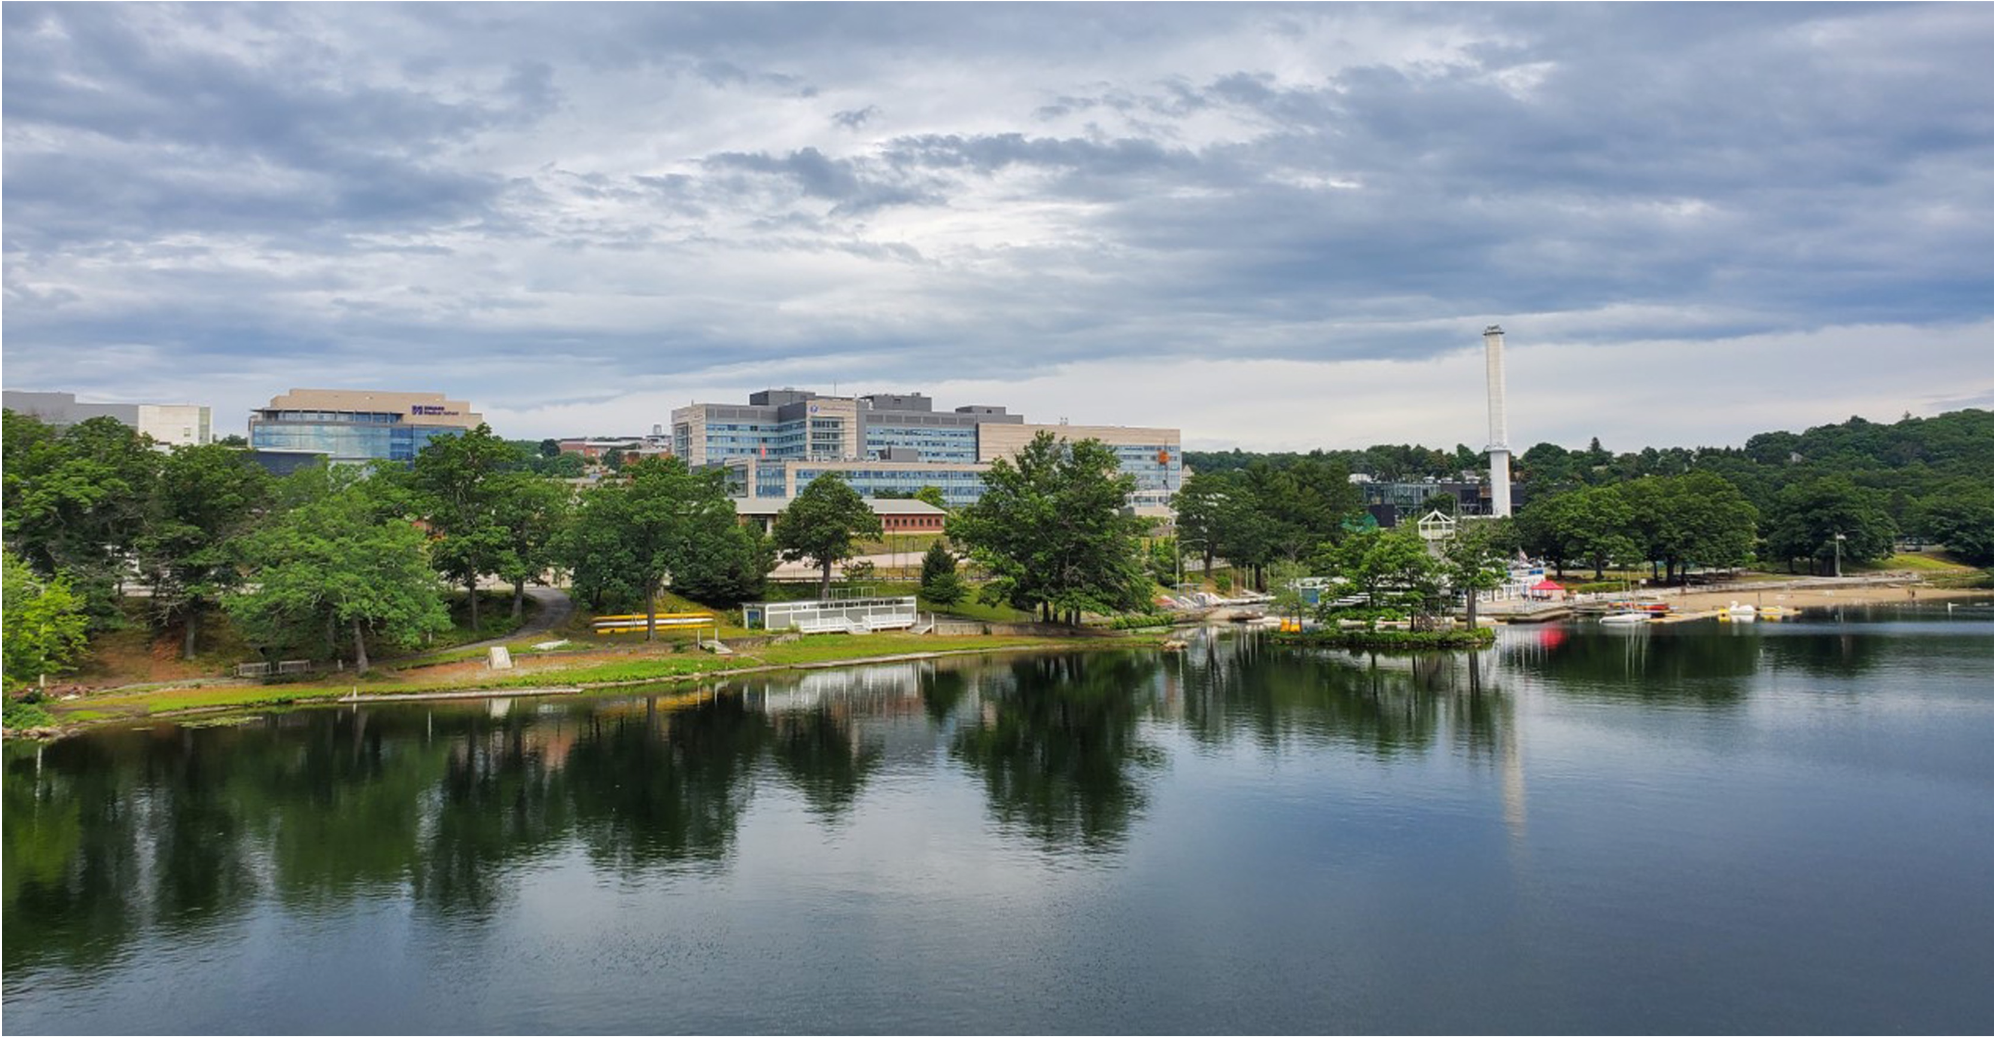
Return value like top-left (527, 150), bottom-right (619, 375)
top-left (0, 0), bottom-right (1994, 451)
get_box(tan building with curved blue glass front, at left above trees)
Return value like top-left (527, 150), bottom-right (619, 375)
top-left (250, 389), bottom-right (484, 463)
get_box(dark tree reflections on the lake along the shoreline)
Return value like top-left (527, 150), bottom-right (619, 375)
top-left (0, 623), bottom-right (1950, 990)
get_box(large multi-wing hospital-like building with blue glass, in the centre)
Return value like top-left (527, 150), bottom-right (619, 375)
top-left (673, 389), bottom-right (1181, 505)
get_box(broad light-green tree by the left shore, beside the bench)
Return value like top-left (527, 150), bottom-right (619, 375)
top-left (224, 467), bottom-right (452, 671)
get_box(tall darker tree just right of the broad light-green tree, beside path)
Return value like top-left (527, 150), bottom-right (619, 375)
top-left (402, 423), bottom-right (523, 631)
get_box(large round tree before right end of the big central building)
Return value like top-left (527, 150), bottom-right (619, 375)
top-left (947, 431), bottom-right (1151, 625)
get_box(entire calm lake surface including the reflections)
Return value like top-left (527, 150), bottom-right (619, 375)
top-left (0, 607), bottom-right (1994, 1034)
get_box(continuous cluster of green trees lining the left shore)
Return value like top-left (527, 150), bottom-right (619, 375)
top-left (4, 411), bottom-right (775, 687)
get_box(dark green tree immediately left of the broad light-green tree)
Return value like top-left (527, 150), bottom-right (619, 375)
top-left (136, 445), bottom-right (270, 657)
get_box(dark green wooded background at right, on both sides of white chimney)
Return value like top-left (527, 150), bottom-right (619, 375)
top-left (1187, 409), bottom-right (1992, 573)
